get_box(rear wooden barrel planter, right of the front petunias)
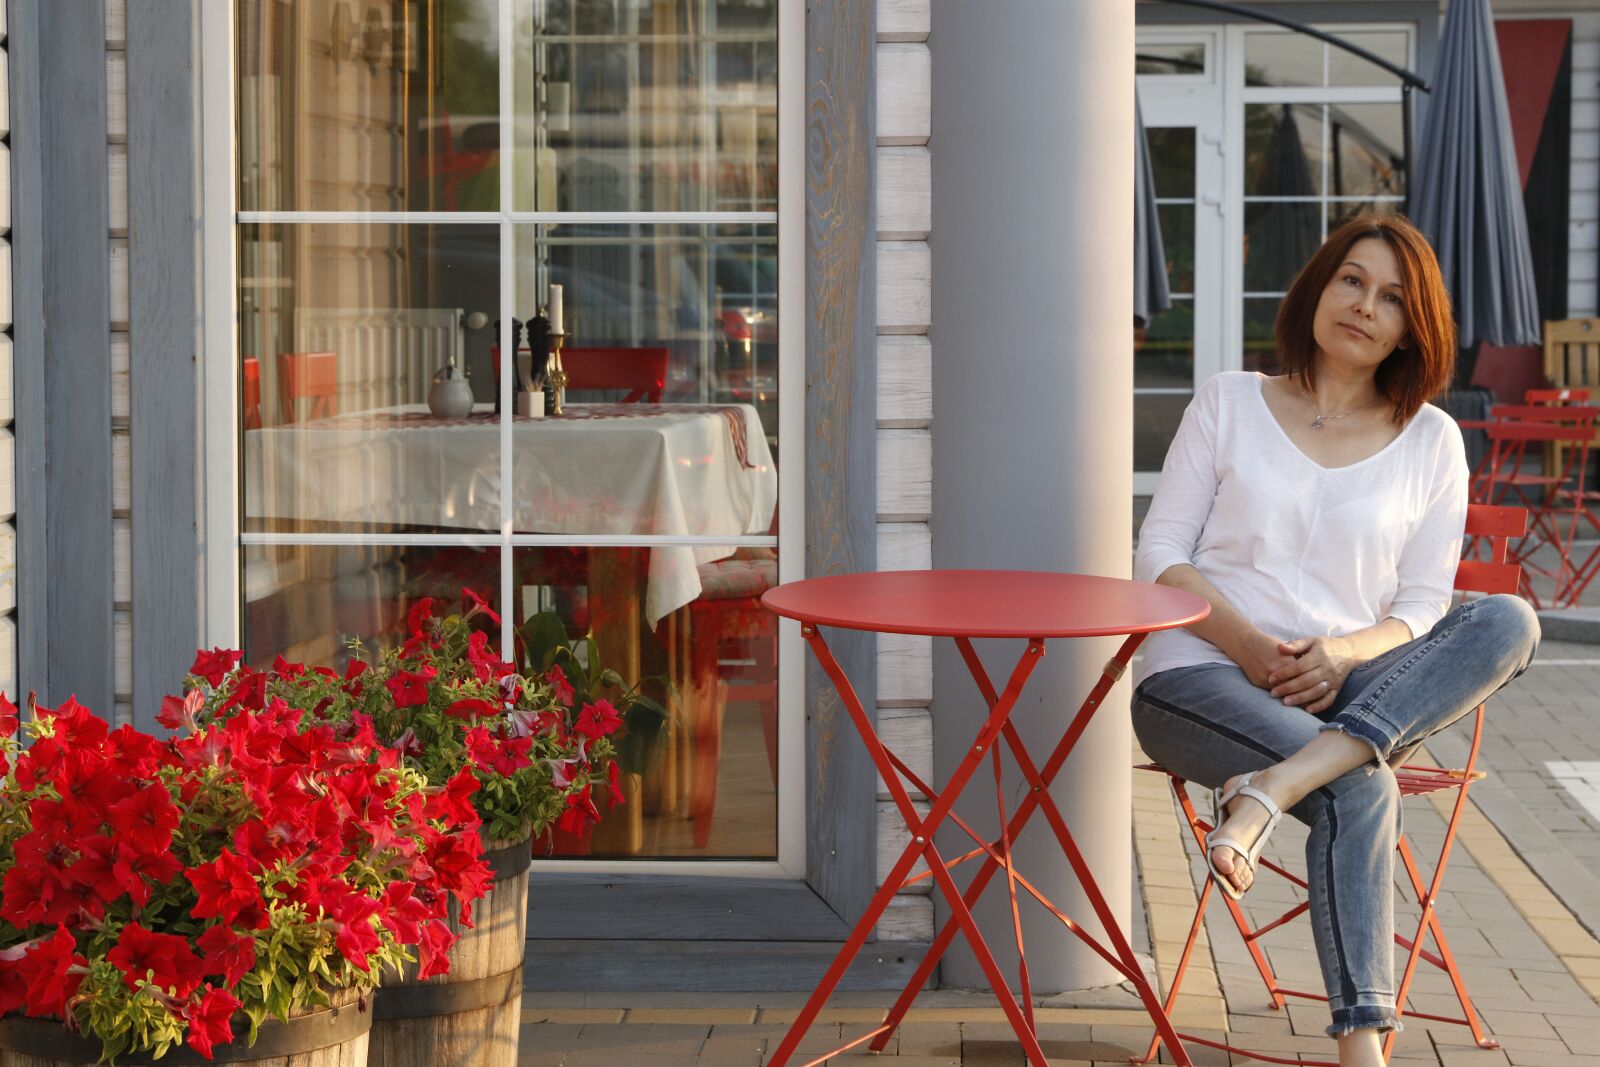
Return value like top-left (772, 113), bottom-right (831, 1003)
top-left (368, 837), bottom-right (531, 1067)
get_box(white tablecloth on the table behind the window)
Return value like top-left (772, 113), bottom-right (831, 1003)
top-left (245, 405), bottom-right (778, 625)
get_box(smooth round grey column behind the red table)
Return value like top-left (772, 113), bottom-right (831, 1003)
top-left (930, 0), bottom-right (1134, 993)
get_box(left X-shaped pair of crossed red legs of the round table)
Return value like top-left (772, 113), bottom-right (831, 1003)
top-left (770, 625), bottom-right (1048, 1067)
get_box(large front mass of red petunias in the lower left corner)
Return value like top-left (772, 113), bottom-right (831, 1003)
top-left (0, 694), bottom-right (490, 1057)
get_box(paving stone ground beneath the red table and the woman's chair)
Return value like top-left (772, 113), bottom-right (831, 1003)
top-left (518, 639), bottom-right (1600, 1067)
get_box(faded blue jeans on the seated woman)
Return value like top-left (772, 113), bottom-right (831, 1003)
top-left (1133, 595), bottom-right (1539, 1037)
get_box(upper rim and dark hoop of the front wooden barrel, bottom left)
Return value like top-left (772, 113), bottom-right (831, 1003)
top-left (0, 1001), bottom-right (373, 1067)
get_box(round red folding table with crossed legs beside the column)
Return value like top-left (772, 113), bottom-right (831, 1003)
top-left (762, 571), bottom-right (1210, 1067)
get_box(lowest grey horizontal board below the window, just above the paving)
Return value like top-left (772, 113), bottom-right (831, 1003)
top-left (522, 940), bottom-right (928, 998)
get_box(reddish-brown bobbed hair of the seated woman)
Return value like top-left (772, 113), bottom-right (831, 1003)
top-left (1274, 213), bottom-right (1456, 426)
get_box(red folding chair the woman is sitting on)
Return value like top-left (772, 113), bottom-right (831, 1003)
top-left (1134, 504), bottom-right (1528, 1067)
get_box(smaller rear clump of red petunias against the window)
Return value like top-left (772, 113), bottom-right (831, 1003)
top-left (178, 589), bottom-right (622, 840)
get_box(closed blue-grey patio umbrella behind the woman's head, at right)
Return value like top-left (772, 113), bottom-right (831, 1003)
top-left (1411, 0), bottom-right (1539, 347)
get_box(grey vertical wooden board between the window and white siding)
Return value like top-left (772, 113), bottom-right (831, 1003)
top-left (805, 0), bottom-right (878, 927)
